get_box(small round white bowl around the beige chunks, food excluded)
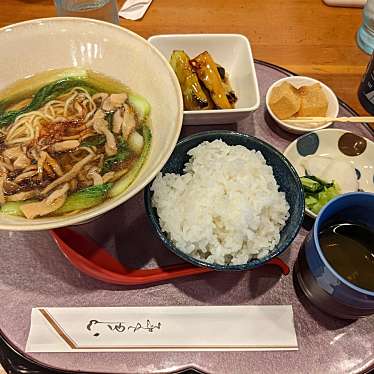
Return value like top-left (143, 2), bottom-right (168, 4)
top-left (266, 76), bottom-right (339, 134)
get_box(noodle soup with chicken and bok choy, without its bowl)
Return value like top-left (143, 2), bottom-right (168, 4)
top-left (0, 71), bottom-right (151, 219)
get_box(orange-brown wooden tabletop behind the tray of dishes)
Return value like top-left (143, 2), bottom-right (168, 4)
top-left (0, 0), bottom-right (369, 373)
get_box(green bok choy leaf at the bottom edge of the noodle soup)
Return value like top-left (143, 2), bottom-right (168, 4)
top-left (54, 183), bottom-right (113, 214)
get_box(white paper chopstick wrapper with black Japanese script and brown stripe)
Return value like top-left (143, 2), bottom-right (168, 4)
top-left (26, 305), bottom-right (298, 352)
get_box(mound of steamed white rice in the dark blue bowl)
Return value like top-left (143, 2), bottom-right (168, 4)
top-left (151, 140), bottom-right (289, 264)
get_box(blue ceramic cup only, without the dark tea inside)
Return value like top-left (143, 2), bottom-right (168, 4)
top-left (294, 192), bottom-right (374, 319)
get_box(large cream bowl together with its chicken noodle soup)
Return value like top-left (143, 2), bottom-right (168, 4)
top-left (0, 18), bottom-right (183, 231)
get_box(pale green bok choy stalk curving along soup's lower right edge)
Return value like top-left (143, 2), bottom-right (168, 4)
top-left (109, 126), bottom-right (152, 197)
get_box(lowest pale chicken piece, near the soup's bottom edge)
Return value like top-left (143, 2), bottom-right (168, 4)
top-left (20, 183), bottom-right (69, 219)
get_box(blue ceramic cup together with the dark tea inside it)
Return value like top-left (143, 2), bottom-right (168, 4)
top-left (294, 192), bottom-right (374, 319)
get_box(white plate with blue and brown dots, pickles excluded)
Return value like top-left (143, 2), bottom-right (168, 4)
top-left (283, 129), bottom-right (374, 218)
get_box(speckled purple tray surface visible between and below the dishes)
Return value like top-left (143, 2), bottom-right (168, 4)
top-left (0, 63), bottom-right (374, 374)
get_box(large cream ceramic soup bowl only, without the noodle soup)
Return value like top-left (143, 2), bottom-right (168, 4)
top-left (0, 17), bottom-right (183, 231)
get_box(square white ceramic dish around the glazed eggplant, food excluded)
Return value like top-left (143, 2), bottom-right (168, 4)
top-left (148, 34), bottom-right (260, 125)
